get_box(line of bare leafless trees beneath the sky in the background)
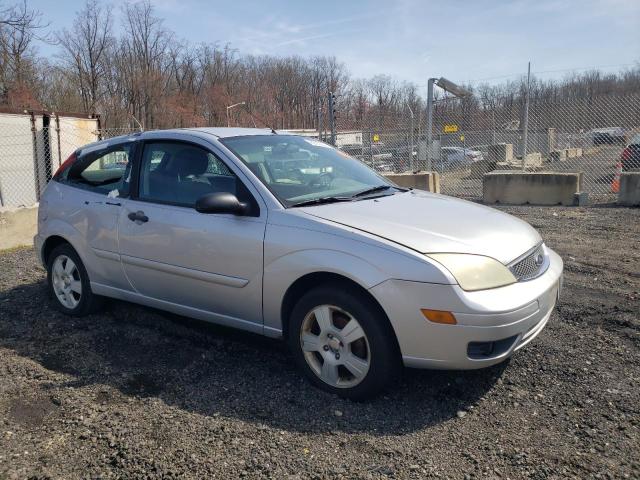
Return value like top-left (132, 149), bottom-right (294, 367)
top-left (0, 0), bottom-right (640, 129)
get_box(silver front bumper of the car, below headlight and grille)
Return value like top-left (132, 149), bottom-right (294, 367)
top-left (371, 249), bottom-right (563, 370)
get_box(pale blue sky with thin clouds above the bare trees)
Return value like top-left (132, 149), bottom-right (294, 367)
top-left (28, 0), bottom-right (640, 92)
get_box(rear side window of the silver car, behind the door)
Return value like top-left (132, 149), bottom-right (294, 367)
top-left (60, 143), bottom-right (133, 196)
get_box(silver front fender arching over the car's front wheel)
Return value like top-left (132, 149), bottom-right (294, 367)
top-left (263, 213), bottom-right (455, 336)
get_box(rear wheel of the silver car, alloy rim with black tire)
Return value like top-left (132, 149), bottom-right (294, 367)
top-left (47, 243), bottom-right (104, 317)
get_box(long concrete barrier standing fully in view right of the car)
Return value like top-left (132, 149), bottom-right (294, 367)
top-left (482, 171), bottom-right (585, 205)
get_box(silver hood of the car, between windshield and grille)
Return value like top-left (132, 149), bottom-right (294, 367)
top-left (300, 190), bottom-right (541, 264)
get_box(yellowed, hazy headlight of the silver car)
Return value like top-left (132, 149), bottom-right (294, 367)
top-left (427, 253), bottom-right (517, 291)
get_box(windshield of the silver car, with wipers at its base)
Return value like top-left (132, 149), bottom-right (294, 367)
top-left (222, 135), bottom-right (399, 207)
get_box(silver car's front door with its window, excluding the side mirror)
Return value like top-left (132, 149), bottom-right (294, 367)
top-left (119, 141), bottom-right (267, 331)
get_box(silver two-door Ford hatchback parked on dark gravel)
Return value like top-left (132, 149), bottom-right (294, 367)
top-left (35, 128), bottom-right (563, 399)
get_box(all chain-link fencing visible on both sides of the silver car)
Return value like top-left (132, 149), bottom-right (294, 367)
top-left (0, 93), bottom-right (640, 207)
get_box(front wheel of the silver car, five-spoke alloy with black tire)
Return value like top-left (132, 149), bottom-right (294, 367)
top-left (288, 285), bottom-right (401, 400)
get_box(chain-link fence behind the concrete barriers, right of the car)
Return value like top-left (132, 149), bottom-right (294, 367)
top-left (338, 94), bottom-right (640, 203)
